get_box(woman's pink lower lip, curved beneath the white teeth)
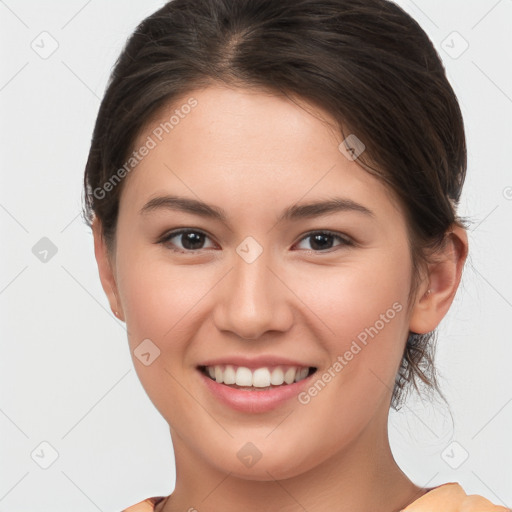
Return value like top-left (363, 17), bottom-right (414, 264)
top-left (197, 370), bottom-right (316, 413)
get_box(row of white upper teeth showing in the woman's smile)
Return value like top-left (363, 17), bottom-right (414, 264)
top-left (202, 364), bottom-right (309, 388)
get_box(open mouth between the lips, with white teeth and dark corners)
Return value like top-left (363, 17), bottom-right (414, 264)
top-left (197, 364), bottom-right (317, 391)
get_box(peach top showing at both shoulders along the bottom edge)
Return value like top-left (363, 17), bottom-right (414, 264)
top-left (122, 482), bottom-right (512, 512)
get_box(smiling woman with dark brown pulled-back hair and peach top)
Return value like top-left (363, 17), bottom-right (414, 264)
top-left (85, 0), bottom-right (506, 512)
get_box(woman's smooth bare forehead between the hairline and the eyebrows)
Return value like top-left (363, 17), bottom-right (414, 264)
top-left (123, 86), bottom-right (404, 224)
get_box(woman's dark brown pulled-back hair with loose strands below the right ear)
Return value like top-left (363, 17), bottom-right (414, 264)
top-left (83, 0), bottom-right (466, 409)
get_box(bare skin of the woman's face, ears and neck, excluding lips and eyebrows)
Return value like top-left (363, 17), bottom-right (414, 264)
top-left (93, 86), bottom-right (467, 512)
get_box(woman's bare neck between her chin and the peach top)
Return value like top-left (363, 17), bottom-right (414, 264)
top-left (156, 415), bottom-right (426, 512)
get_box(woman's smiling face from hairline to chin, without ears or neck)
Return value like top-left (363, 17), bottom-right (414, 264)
top-left (98, 87), bottom-right (422, 480)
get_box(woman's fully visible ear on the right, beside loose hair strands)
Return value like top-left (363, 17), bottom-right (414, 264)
top-left (409, 225), bottom-right (468, 334)
